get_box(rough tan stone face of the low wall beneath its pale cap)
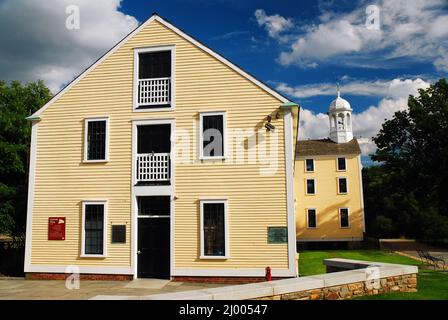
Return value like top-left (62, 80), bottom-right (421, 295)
top-left (257, 274), bottom-right (417, 300)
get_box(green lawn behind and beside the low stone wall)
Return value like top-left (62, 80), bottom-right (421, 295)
top-left (299, 250), bottom-right (448, 300)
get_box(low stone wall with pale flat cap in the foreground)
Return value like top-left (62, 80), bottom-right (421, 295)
top-left (92, 259), bottom-right (418, 300)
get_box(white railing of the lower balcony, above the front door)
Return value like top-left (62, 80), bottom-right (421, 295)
top-left (137, 153), bottom-right (170, 182)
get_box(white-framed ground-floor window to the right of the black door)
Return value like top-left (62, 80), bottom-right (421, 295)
top-left (201, 201), bottom-right (227, 258)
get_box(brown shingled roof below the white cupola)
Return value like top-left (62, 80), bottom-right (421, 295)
top-left (296, 138), bottom-right (361, 158)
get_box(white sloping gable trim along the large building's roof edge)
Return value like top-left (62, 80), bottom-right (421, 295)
top-left (27, 13), bottom-right (290, 121)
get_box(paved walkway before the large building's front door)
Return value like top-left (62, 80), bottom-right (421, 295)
top-left (0, 278), bottom-right (226, 300)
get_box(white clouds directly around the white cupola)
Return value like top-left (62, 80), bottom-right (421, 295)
top-left (277, 79), bottom-right (429, 155)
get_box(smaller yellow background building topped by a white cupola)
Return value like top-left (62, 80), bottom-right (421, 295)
top-left (294, 89), bottom-right (365, 244)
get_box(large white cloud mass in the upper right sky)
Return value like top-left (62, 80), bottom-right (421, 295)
top-left (256, 0), bottom-right (448, 71)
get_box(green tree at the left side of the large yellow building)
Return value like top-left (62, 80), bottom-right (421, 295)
top-left (0, 81), bottom-right (51, 237)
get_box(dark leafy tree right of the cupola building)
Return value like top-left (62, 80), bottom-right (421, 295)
top-left (363, 79), bottom-right (448, 240)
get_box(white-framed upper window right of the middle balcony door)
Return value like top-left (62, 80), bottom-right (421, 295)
top-left (200, 112), bottom-right (226, 159)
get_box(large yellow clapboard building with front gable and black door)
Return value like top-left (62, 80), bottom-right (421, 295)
top-left (25, 14), bottom-right (298, 281)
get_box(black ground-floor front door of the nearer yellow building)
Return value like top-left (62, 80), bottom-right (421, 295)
top-left (137, 217), bottom-right (170, 279)
